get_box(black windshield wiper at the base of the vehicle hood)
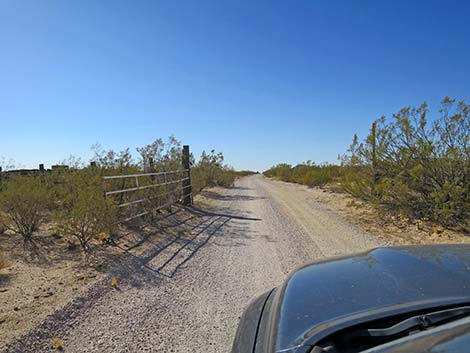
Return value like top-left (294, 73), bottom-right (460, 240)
top-left (358, 306), bottom-right (470, 337)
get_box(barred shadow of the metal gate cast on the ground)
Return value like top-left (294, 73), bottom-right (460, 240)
top-left (99, 207), bottom-right (261, 287)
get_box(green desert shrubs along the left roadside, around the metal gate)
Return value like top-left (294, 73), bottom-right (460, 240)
top-left (0, 136), bottom-right (242, 253)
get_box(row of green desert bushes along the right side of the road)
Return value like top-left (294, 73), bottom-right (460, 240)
top-left (264, 97), bottom-right (470, 231)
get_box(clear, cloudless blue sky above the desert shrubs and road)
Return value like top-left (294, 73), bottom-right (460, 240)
top-left (0, 0), bottom-right (470, 171)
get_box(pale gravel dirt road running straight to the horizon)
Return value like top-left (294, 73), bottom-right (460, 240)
top-left (8, 175), bottom-right (383, 353)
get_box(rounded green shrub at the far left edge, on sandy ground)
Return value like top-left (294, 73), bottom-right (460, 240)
top-left (0, 176), bottom-right (50, 242)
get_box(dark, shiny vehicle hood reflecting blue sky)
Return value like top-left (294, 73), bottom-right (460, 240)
top-left (270, 244), bottom-right (470, 352)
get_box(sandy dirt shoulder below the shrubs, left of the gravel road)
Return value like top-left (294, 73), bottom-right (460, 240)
top-left (0, 195), bottom-right (217, 350)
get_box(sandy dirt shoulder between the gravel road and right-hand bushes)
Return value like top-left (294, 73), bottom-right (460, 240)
top-left (305, 182), bottom-right (470, 245)
